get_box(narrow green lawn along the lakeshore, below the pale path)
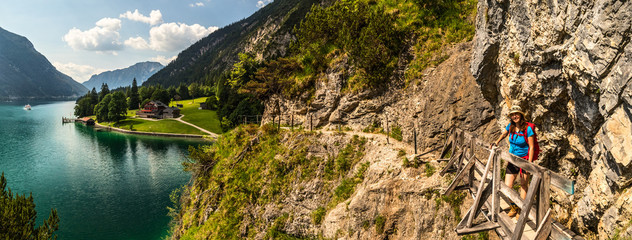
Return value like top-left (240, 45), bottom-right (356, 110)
top-left (110, 118), bottom-right (205, 135)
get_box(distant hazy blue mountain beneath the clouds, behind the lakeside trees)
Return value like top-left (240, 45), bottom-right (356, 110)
top-left (82, 62), bottom-right (164, 91)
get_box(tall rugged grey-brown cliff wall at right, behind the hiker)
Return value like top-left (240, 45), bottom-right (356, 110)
top-left (471, 0), bottom-right (632, 238)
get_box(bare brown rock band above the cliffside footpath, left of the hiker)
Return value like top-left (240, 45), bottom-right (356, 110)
top-left (264, 43), bottom-right (500, 148)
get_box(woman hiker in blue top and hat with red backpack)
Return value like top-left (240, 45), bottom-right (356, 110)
top-left (492, 105), bottom-right (536, 217)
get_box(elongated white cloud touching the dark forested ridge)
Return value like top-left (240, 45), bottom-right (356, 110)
top-left (125, 23), bottom-right (218, 52)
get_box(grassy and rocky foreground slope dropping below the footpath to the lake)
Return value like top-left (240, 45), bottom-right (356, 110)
top-left (173, 124), bottom-right (470, 239)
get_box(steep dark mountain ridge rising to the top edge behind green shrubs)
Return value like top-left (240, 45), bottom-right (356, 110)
top-left (144, 0), bottom-right (319, 87)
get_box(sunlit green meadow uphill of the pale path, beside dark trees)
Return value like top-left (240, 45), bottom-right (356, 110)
top-left (170, 97), bottom-right (222, 134)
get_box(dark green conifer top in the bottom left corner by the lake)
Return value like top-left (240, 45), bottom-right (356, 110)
top-left (0, 172), bottom-right (59, 240)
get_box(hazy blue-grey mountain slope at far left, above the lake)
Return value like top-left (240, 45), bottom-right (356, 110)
top-left (0, 28), bottom-right (88, 100)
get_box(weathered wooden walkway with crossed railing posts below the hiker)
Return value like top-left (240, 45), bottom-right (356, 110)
top-left (439, 128), bottom-right (583, 240)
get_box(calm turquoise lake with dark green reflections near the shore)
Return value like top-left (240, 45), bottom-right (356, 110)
top-left (0, 102), bottom-right (208, 240)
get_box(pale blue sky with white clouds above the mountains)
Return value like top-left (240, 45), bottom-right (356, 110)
top-left (0, 0), bottom-right (273, 82)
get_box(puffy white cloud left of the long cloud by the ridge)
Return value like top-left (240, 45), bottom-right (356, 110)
top-left (63, 18), bottom-right (123, 52)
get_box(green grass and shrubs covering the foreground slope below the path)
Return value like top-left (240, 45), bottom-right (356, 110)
top-left (171, 125), bottom-right (369, 239)
